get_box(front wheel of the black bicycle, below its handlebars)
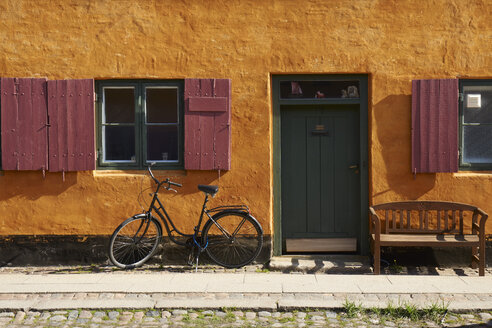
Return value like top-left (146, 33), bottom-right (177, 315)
top-left (109, 215), bottom-right (162, 269)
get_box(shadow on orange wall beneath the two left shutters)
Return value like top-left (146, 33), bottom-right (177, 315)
top-left (0, 171), bottom-right (77, 201)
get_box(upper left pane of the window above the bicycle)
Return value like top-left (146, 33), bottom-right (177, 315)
top-left (103, 88), bottom-right (135, 123)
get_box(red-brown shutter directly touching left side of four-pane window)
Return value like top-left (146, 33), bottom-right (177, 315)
top-left (48, 79), bottom-right (96, 172)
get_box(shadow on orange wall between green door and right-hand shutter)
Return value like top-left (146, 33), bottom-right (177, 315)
top-left (371, 95), bottom-right (436, 201)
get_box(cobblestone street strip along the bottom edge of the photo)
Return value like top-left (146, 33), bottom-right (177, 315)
top-left (0, 309), bottom-right (492, 328)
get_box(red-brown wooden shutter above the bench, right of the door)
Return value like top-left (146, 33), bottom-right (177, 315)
top-left (412, 79), bottom-right (458, 173)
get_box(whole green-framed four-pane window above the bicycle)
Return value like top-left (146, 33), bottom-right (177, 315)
top-left (95, 80), bottom-right (184, 170)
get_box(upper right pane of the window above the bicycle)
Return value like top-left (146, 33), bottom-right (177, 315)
top-left (145, 88), bottom-right (178, 123)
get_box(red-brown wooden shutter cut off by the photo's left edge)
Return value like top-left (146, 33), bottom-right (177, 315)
top-left (0, 78), bottom-right (48, 170)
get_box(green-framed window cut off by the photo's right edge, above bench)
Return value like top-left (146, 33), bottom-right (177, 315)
top-left (459, 80), bottom-right (492, 171)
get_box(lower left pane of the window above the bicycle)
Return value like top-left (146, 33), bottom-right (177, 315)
top-left (103, 126), bottom-right (135, 162)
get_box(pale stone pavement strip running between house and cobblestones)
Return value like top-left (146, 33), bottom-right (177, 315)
top-left (0, 272), bottom-right (492, 310)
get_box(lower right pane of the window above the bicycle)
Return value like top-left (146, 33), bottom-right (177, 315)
top-left (147, 125), bottom-right (178, 161)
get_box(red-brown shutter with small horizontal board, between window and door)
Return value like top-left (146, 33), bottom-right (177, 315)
top-left (184, 79), bottom-right (231, 170)
